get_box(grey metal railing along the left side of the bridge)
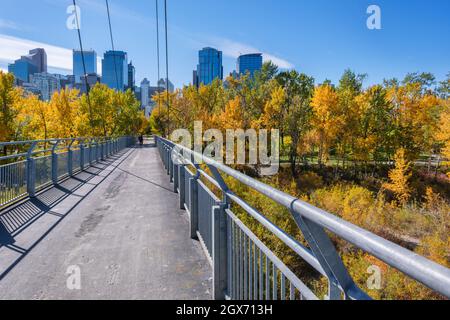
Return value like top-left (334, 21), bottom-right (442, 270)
top-left (0, 137), bottom-right (134, 208)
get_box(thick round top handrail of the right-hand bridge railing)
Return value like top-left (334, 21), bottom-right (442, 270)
top-left (157, 137), bottom-right (450, 297)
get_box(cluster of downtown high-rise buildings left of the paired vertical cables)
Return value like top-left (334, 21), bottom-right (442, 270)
top-left (8, 48), bottom-right (175, 100)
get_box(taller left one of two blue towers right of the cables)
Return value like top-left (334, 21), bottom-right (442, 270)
top-left (193, 48), bottom-right (223, 85)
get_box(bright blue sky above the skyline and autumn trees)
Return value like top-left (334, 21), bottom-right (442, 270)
top-left (0, 0), bottom-right (450, 87)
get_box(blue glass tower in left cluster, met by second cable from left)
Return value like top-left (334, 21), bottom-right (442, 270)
top-left (102, 51), bottom-right (128, 91)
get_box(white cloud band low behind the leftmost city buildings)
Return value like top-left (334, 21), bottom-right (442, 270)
top-left (0, 34), bottom-right (102, 74)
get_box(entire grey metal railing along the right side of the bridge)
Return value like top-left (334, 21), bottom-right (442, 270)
top-left (156, 137), bottom-right (450, 300)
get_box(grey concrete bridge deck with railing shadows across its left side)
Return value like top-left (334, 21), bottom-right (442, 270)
top-left (0, 141), bottom-right (211, 299)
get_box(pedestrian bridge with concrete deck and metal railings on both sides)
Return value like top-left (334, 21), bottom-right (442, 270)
top-left (0, 137), bottom-right (450, 300)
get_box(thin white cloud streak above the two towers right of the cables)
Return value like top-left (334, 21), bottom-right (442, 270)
top-left (208, 37), bottom-right (294, 69)
